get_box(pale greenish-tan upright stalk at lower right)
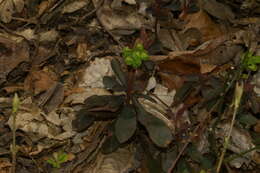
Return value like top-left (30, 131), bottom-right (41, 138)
top-left (216, 83), bottom-right (243, 173)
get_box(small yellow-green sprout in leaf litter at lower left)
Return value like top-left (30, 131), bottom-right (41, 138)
top-left (47, 152), bottom-right (68, 168)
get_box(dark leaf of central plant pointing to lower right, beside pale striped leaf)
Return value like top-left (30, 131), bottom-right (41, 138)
top-left (135, 98), bottom-right (173, 147)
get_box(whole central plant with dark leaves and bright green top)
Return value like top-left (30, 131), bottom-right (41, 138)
top-left (73, 44), bottom-right (173, 153)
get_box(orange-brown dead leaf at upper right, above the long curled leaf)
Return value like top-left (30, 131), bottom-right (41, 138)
top-left (184, 10), bottom-right (224, 42)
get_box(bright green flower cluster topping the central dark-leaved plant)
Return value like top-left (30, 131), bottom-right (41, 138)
top-left (123, 43), bottom-right (149, 68)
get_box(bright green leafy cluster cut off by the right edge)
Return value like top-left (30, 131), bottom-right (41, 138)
top-left (243, 51), bottom-right (260, 71)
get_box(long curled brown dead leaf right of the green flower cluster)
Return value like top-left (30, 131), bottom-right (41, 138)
top-left (150, 36), bottom-right (243, 75)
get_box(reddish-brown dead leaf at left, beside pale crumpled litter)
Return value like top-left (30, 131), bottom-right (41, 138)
top-left (24, 70), bottom-right (57, 95)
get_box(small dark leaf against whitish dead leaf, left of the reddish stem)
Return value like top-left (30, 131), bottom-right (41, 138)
top-left (103, 76), bottom-right (126, 92)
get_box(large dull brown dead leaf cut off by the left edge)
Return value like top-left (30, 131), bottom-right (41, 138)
top-left (0, 36), bottom-right (29, 84)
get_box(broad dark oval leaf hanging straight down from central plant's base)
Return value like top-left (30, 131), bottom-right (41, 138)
top-left (115, 105), bottom-right (137, 143)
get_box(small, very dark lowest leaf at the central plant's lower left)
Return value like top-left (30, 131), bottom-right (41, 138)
top-left (101, 135), bottom-right (120, 154)
